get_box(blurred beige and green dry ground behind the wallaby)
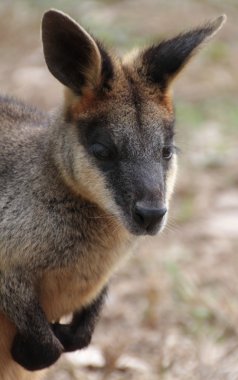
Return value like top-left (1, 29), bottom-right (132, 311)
top-left (0, 0), bottom-right (238, 380)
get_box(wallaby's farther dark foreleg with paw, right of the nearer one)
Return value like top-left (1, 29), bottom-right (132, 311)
top-left (52, 288), bottom-right (107, 352)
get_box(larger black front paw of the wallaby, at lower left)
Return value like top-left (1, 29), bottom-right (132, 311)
top-left (11, 334), bottom-right (63, 371)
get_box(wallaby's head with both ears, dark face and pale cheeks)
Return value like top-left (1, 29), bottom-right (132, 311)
top-left (42, 10), bottom-right (225, 235)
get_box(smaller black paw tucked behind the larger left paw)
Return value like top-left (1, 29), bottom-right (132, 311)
top-left (51, 323), bottom-right (92, 352)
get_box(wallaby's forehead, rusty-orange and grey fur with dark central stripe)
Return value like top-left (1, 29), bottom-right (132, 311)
top-left (74, 68), bottom-right (174, 154)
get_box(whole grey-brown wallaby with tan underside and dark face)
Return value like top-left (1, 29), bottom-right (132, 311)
top-left (0, 10), bottom-right (225, 380)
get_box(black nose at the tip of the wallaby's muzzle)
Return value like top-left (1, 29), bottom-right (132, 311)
top-left (134, 202), bottom-right (167, 233)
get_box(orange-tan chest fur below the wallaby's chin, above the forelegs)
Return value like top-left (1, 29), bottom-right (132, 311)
top-left (38, 230), bottom-right (131, 321)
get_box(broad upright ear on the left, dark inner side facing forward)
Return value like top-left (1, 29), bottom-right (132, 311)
top-left (42, 10), bottom-right (113, 95)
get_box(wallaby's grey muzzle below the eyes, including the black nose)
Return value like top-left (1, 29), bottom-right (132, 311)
top-left (109, 159), bottom-right (167, 235)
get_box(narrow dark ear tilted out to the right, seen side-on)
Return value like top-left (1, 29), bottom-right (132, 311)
top-left (135, 15), bottom-right (226, 92)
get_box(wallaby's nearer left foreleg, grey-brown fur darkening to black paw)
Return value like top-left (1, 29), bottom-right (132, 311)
top-left (0, 270), bottom-right (63, 371)
